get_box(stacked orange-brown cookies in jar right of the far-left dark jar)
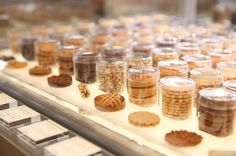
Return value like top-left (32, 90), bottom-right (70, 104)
top-left (36, 40), bottom-right (57, 66)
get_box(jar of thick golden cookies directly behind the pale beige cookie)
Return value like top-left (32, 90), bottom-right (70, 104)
top-left (128, 67), bottom-right (159, 106)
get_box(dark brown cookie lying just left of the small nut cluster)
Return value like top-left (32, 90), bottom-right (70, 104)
top-left (48, 74), bottom-right (72, 87)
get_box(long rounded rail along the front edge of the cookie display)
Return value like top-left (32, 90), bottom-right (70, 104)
top-left (0, 65), bottom-right (162, 155)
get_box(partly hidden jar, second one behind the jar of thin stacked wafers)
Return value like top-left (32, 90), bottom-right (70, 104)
top-left (152, 47), bottom-right (178, 67)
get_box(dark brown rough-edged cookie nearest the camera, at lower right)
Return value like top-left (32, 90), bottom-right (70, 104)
top-left (165, 130), bottom-right (203, 147)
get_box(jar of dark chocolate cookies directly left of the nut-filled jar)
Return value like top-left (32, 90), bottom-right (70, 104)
top-left (73, 51), bottom-right (101, 83)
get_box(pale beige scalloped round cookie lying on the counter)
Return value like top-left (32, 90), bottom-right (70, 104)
top-left (128, 112), bottom-right (160, 127)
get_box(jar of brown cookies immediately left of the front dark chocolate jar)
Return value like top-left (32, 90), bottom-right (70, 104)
top-left (58, 45), bottom-right (77, 75)
